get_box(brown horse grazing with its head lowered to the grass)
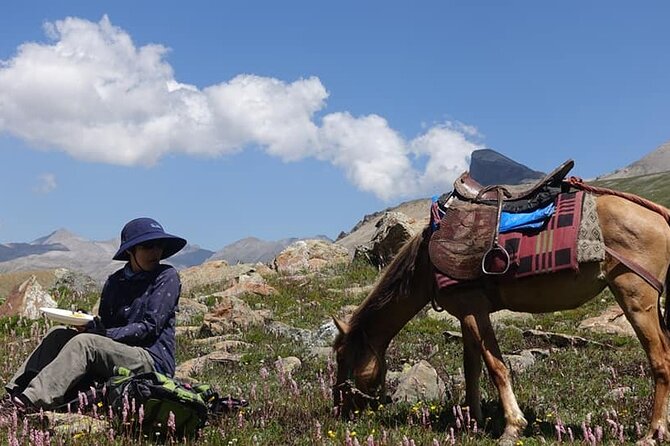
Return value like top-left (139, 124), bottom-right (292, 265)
top-left (333, 195), bottom-right (670, 444)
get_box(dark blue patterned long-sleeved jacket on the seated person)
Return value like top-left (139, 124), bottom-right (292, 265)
top-left (98, 265), bottom-right (181, 376)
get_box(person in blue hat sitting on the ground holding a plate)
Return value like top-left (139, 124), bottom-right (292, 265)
top-left (5, 218), bottom-right (186, 412)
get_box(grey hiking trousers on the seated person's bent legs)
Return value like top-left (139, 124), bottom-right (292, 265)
top-left (5, 326), bottom-right (155, 409)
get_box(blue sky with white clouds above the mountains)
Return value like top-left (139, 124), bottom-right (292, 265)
top-left (0, 0), bottom-right (670, 250)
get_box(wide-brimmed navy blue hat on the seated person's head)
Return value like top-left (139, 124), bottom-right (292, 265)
top-left (113, 217), bottom-right (186, 260)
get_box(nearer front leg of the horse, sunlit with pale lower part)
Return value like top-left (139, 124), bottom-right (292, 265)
top-left (461, 312), bottom-right (528, 445)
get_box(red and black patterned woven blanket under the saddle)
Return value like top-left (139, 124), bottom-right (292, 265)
top-left (435, 191), bottom-right (584, 288)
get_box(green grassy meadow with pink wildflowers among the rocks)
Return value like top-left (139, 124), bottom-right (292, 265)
top-left (0, 174), bottom-right (670, 446)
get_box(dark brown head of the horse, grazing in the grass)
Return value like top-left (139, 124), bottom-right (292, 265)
top-left (333, 318), bottom-right (386, 417)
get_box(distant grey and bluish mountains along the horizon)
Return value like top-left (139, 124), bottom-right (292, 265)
top-left (0, 142), bottom-right (670, 282)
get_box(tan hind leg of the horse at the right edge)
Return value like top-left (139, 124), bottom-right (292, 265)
top-left (610, 274), bottom-right (670, 440)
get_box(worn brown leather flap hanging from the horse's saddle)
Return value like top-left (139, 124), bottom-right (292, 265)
top-left (428, 201), bottom-right (497, 280)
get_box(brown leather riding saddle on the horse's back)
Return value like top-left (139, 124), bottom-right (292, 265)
top-left (428, 160), bottom-right (575, 280)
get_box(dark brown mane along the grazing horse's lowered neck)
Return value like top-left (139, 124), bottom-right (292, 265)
top-left (349, 226), bottom-right (431, 333)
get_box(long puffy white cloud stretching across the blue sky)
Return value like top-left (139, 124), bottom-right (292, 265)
top-left (0, 16), bottom-right (480, 199)
